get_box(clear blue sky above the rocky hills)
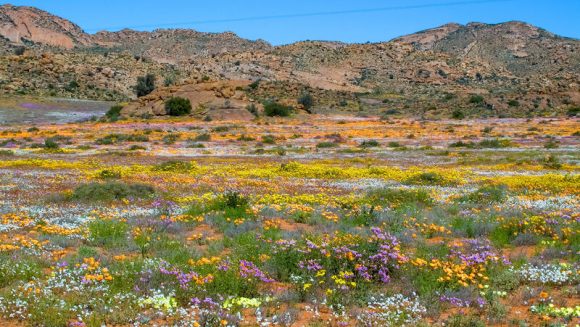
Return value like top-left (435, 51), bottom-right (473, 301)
top-left (5, 0), bottom-right (580, 44)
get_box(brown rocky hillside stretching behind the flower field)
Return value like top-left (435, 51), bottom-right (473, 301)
top-left (0, 5), bottom-right (580, 117)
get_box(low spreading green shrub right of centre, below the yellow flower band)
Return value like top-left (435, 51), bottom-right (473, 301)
top-left (367, 188), bottom-right (433, 207)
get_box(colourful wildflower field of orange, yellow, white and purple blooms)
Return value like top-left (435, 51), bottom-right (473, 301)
top-left (0, 115), bottom-right (580, 326)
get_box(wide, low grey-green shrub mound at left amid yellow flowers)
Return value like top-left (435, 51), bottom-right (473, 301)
top-left (71, 182), bottom-right (155, 201)
